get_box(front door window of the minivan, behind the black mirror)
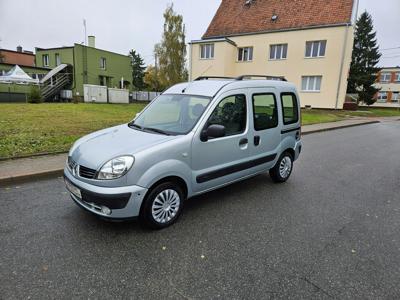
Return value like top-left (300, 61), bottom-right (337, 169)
top-left (207, 94), bottom-right (247, 136)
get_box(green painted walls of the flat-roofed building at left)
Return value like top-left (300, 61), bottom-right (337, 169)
top-left (36, 44), bottom-right (132, 97)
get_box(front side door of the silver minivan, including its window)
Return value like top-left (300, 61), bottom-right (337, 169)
top-left (192, 91), bottom-right (249, 193)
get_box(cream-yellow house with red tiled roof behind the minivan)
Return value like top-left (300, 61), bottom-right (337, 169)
top-left (189, 0), bottom-right (357, 109)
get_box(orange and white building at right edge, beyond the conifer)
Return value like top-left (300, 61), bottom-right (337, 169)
top-left (374, 67), bottom-right (400, 107)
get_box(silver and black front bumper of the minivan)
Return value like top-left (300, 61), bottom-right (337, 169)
top-left (64, 168), bottom-right (147, 219)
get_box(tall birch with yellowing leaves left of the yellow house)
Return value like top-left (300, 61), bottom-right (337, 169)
top-left (154, 4), bottom-right (187, 87)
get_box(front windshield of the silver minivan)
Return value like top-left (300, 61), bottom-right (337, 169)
top-left (129, 94), bottom-right (211, 135)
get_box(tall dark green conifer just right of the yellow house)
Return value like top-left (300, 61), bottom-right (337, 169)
top-left (347, 11), bottom-right (381, 105)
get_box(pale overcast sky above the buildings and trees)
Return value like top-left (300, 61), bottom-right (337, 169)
top-left (0, 0), bottom-right (400, 66)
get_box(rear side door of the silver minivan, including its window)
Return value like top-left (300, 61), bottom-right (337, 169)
top-left (248, 88), bottom-right (281, 172)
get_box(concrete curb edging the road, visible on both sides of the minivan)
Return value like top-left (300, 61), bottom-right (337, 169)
top-left (0, 120), bottom-right (380, 187)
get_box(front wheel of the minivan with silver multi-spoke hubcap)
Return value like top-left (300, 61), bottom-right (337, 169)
top-left (139, 182), bottom-right (185, 229)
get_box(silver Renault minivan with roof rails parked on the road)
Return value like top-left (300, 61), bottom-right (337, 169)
top-left (64, 76), bottom-right (302, 228)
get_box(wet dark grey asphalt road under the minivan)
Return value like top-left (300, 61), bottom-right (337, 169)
top-left (0, 122), bottom-right (400, 299)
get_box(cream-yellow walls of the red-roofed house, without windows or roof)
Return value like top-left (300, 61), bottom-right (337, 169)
top-left (191, 26), bottom-right (353, 109)
